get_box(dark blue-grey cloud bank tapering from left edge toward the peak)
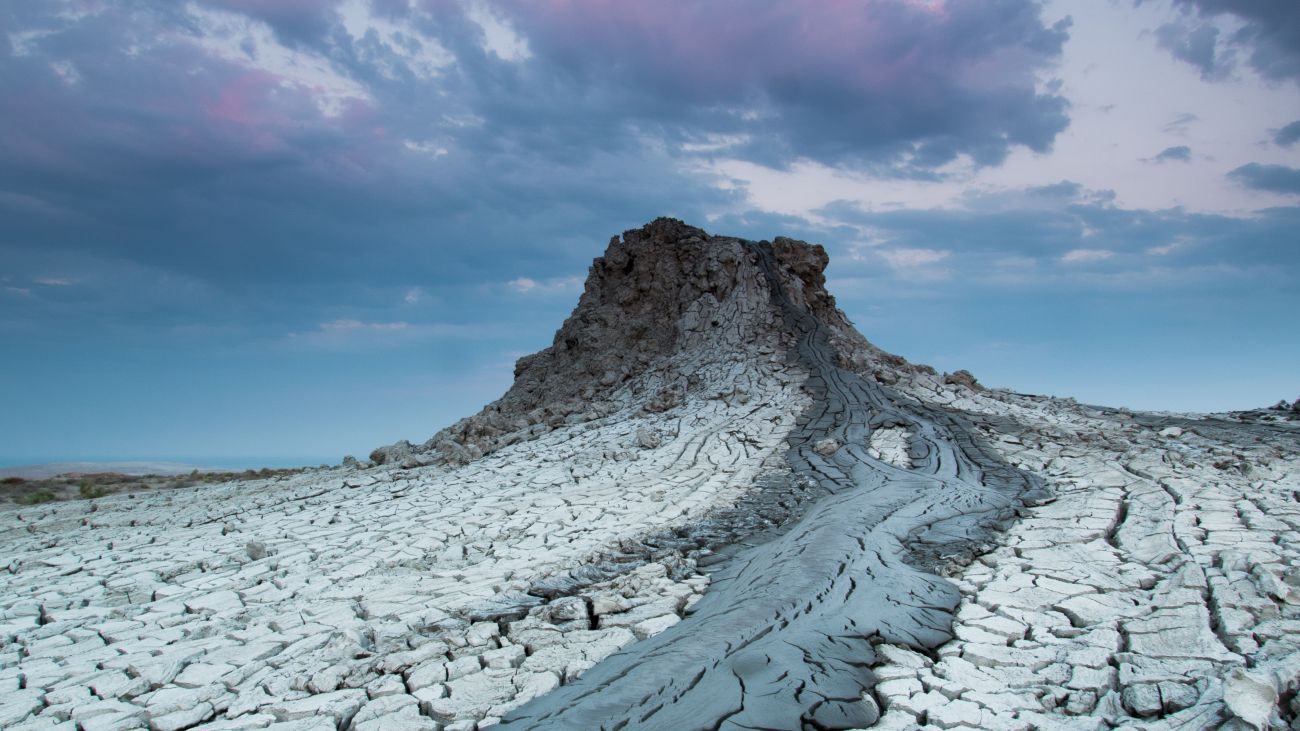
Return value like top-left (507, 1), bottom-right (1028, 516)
top-left (0, 4), bottom-right (727, 296)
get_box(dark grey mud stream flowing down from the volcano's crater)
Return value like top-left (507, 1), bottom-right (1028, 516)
top-left (503, 243), bottom-right (1043, 730)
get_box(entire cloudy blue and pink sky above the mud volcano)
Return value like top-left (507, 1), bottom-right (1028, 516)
top-left (0, 0), bottom-right (1300, 464)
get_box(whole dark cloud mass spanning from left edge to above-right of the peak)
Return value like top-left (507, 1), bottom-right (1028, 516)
top-left (0, 0), bottom-right (1067, 335)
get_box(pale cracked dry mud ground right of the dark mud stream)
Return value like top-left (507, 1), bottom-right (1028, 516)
top-left (875, 380), bottom-right (1300, 731)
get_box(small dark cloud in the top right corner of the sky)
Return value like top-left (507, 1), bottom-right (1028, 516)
top-left (1159, 0), bottom-right (1300, 81)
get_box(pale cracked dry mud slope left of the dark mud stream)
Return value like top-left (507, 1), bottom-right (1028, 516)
top-left (0, 353), bottom-right (805, 728)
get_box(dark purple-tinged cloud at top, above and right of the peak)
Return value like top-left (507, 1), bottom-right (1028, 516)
top-left (491, 0), bottom-right (1069, 172)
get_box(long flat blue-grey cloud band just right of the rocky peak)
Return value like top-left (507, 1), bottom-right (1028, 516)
top-left (811, 187), bottom-right (1300, 292)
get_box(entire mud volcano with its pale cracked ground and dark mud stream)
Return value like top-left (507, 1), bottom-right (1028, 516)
top-left (0, 220), bottom-right (1300, 730)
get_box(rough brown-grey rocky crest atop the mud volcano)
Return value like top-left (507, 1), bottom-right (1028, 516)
top-left (371, 219), bottom-right (902, 464)
